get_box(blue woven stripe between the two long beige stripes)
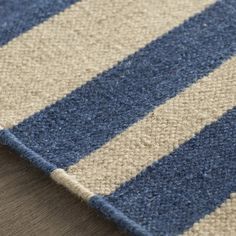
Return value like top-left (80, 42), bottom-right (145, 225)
top-left (7, 0), bottom-right (236, 168)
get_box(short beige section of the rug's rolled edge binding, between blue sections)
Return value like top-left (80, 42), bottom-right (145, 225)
top-left (50, 169), bottom-right (94, 201)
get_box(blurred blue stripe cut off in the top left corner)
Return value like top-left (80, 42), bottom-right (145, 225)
top-left (0, 0), bottom-right (78, 46)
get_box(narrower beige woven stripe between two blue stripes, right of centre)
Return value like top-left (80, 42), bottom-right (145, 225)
top-left (68, 57), bottom-right (236, 194)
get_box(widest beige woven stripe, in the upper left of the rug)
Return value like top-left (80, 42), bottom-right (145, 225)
top-left (0, 0), bottom-right (214, 127)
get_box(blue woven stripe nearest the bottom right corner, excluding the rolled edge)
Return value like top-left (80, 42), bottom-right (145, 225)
top-left (102, 107), bottom-right (236, 235)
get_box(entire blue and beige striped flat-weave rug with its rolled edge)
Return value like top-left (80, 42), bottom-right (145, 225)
top-left (0, 0), bottom-right (236, 236)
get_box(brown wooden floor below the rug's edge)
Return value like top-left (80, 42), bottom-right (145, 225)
top-left (0, 146), bottom-right (124, 236)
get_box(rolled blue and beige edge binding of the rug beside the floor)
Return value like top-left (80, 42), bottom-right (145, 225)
top-left (0, 126), bottom-right (149, 236)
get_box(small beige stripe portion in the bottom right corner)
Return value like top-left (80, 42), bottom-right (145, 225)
top-left (184, 193), bottom-right (236, 236)
